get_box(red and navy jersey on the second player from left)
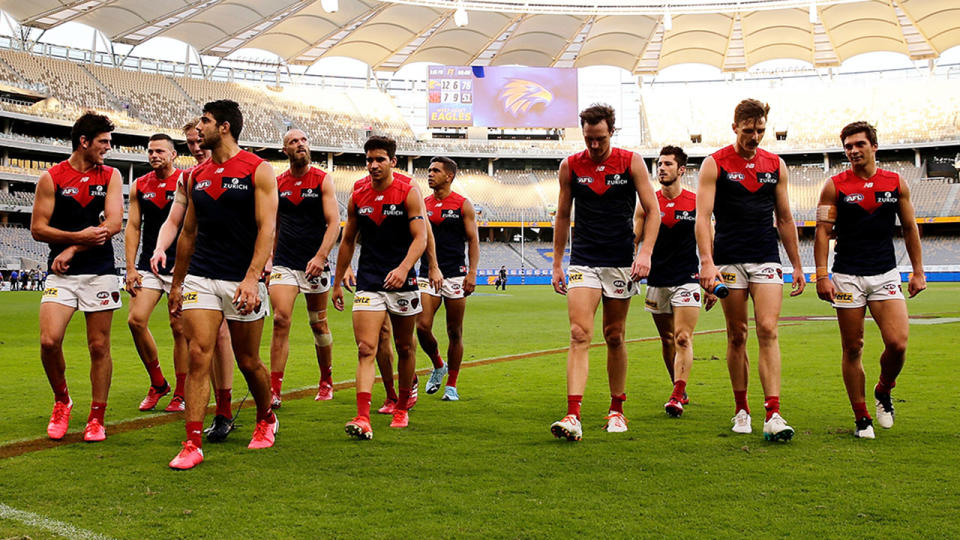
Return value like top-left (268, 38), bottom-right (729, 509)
top-left (134, 169), bottom-right (182, 274)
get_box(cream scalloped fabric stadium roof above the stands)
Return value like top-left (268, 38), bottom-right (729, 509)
top-left (0, 0), bottom-right (960, 73)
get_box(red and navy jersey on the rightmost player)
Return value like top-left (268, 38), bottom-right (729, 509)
top-left (830, 169), bottom-right (900, 276)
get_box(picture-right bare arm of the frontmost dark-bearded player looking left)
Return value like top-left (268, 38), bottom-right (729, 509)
top-left (233, 161), bottom-right (279, 315)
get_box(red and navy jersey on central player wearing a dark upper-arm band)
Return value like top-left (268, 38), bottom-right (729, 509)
top-left (351, 177), bottom-right (417, 291)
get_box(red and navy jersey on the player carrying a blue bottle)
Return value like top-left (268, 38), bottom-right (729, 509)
top-left (713, 145), bottom-right (780, 264)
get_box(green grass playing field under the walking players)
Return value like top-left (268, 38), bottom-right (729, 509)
top-left (0, 284), bottom-right (960, 538)
